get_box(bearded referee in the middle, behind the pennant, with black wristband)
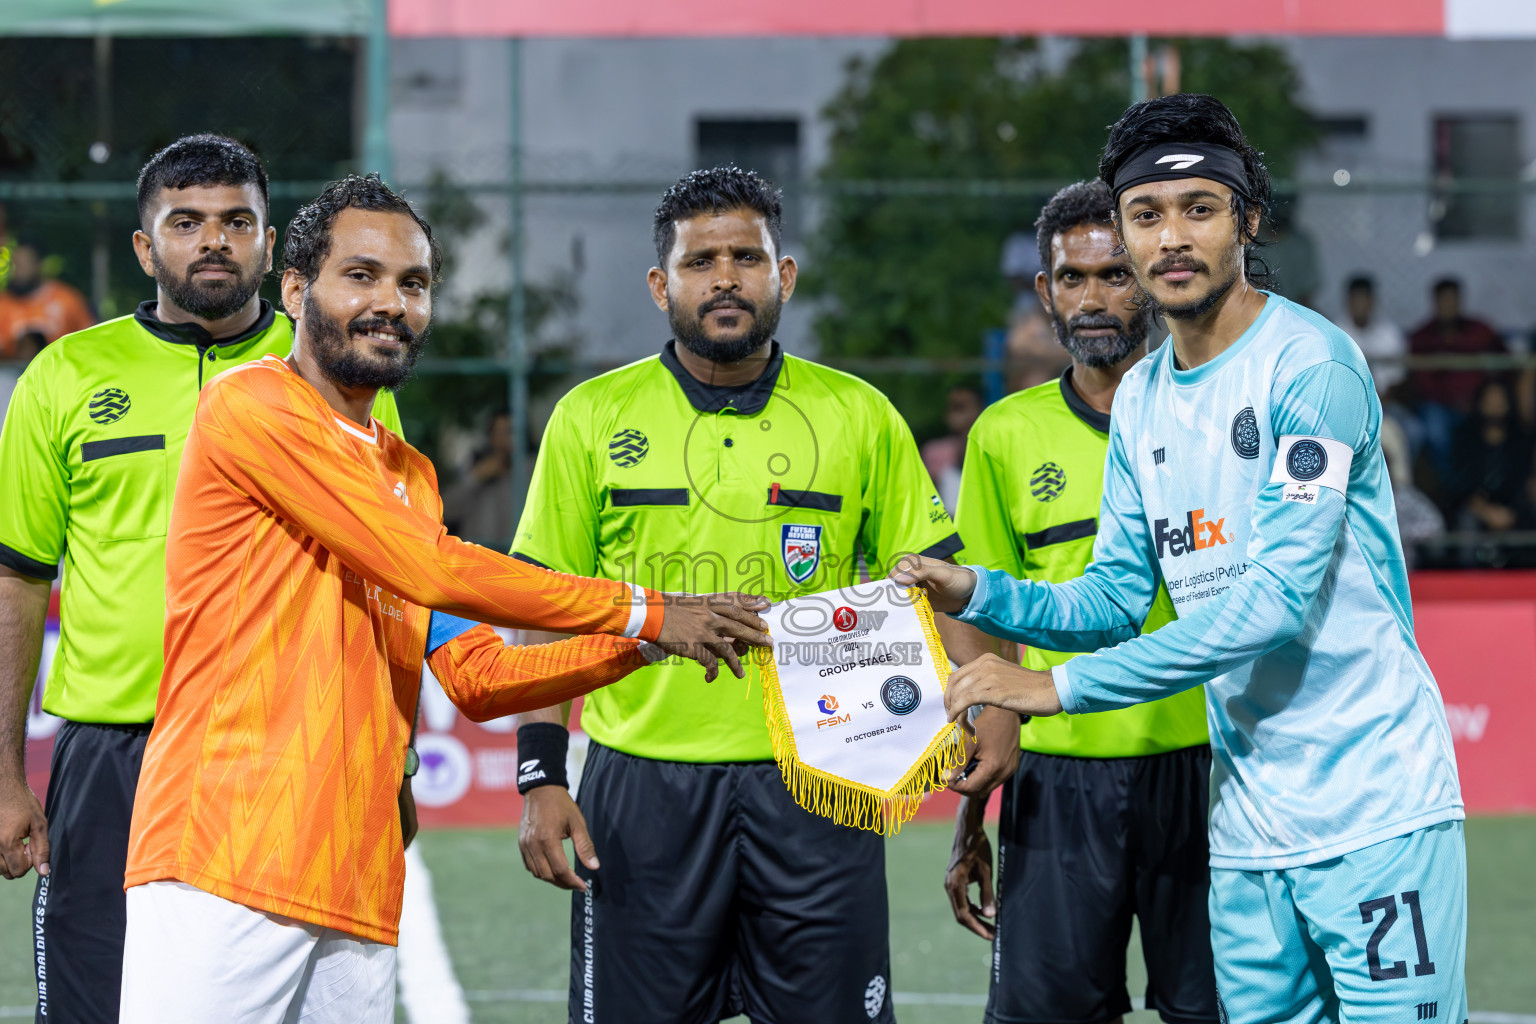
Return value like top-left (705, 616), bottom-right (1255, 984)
top-left (513, 167), bottom-right (960, 1024)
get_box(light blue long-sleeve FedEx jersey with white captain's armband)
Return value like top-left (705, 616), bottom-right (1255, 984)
top-left (958, 295), bottom-right (1464, 870)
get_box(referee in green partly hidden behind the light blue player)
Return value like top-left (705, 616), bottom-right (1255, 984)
top-left (945, 181), bottom-right (1217, 1024)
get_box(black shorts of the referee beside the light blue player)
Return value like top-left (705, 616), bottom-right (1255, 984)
top-left (985, 746), bottom-right (1217, 1024)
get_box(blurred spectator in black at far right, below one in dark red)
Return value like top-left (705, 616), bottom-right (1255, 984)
top-left (1445, 378), bottom-right (1531, 533)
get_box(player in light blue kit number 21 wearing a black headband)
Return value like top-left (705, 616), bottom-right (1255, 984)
top-left (892, 95), bottom-right (1467, 1024)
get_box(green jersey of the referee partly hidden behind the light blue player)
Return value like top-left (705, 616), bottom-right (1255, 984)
top-left (955, 370), bottom-right (1209, 757)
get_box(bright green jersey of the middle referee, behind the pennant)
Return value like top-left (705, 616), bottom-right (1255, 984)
top-left (513, 342), bottom-right (960, 761)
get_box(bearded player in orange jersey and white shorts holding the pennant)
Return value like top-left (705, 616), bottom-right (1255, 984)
top-left (121, 177), bottom-right (766, 1024)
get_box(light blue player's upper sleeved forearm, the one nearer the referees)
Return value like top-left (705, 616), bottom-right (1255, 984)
top-left (955, 567), bottom-right (1138, 651)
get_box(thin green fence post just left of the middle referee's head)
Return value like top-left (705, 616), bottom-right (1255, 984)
top-left (507, 35), bottom-right (528, 528)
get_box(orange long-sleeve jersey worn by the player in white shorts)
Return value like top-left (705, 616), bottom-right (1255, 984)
top-left (126, 356), bottom-right (662, 943)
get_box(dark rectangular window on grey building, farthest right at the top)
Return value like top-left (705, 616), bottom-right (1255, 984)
top-left (1430, 115), bottom-right (1521, 238)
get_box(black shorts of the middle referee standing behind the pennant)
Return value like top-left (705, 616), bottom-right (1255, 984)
top-left (570, 743), bottom-right (895, 1024)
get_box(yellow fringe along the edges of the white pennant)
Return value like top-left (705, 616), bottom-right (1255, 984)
top-left (762, 586), bottom-right (965, 835)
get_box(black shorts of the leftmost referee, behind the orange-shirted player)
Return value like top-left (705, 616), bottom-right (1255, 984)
top-left (32, 722), bottom-right (149, 1024)
